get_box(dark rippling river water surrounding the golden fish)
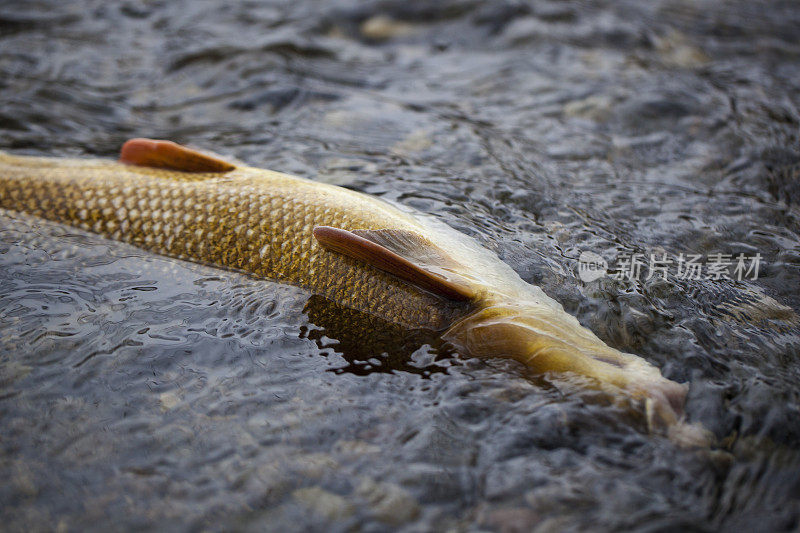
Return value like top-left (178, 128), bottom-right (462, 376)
top-left (0, 0), bottom-right (800, 532)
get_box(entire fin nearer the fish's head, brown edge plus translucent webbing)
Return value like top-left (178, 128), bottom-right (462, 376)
top-left (314, 226), bottom-right (475, 301)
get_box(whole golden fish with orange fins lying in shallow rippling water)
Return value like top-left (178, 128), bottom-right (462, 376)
top-left (0, 140), bottom-right (708, 440)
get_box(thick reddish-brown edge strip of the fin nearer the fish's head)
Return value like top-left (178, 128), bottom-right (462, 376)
top-left (314, 226), bottom-right (475, 301)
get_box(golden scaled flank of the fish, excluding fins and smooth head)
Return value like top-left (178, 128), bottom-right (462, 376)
top-left (0, 153), bottom-right (466, 330)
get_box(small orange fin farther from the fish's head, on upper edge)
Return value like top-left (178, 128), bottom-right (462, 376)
top-left (119, 139), bottom-right (236, 172)
